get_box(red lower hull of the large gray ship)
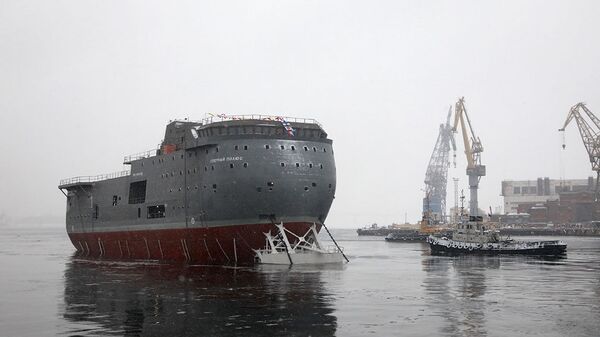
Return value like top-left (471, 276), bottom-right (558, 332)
top-left (69, 222), bottom-right (320, 265)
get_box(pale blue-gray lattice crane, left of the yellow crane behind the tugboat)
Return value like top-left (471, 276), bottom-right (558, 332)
top-left (423, 106), bottom-right (456, 222)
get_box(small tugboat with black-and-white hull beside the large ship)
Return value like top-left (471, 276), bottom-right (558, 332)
top-left (427, 221), bottom-right (567, 255)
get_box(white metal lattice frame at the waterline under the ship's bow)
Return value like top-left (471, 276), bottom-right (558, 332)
top-left (254, 223), bottom-right (348, 265)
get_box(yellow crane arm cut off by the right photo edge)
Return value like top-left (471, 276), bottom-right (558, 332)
top-left (558, 102), bottom-right (600, 197)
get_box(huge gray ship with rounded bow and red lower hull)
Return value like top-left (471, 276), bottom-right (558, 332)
top-left (59, 115), bottom-right (336, 264)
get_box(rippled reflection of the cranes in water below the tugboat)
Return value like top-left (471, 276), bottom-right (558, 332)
top-left (422, 256), bottom-right (500, 336)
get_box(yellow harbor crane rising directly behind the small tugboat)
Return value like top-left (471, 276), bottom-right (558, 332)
top-left (452, 97), bottom-right (485, 218)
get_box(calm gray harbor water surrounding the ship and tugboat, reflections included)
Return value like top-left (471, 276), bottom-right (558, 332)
top-left (0, 228), bottom-right (600, 336)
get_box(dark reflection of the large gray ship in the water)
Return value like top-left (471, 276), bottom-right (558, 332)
top-left (62, 258), bottom-right (337, 336)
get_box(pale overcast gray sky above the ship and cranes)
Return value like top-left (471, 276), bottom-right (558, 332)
top-left (0, 0), bottom-right (600, 227)
